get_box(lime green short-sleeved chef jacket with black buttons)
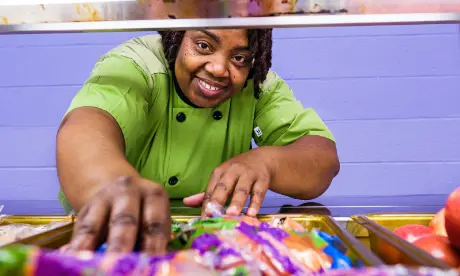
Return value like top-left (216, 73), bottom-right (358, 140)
top-left (59, 34), bottom-right (334, 211)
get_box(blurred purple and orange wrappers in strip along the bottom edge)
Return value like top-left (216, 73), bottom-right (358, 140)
top-left (0, 246), bottom-right (459, 276)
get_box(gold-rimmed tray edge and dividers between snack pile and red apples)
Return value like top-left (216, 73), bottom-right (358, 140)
top-left (347, 213), bottom-right (451, 269)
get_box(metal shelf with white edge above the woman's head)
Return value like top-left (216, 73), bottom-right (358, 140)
top-left (0, 0), bottom-right (460, 34)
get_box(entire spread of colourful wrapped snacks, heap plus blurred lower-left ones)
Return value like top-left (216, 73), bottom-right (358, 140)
top-left (0, 209), bottom-right (367, 276)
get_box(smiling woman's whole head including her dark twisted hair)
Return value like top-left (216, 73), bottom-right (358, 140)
top-left (163, 29), bottom-right (272, 107)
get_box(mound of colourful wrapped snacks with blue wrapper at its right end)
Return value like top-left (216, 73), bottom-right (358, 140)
top-left (166, 216), bottom-right (352, 275)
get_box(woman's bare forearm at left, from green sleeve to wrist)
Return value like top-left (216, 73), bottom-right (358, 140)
top-left (56, 107), bottom-right (139, 211)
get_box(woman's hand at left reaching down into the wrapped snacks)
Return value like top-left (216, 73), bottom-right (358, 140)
top-left (67, 177), bottom-right (171, 254)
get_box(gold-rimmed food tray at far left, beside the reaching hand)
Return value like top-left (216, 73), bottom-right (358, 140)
top-left (0, 216), bottom-right (75, 248)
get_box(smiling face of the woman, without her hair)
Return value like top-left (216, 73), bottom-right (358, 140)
top-left (174, 29), bottom-right (252, 107)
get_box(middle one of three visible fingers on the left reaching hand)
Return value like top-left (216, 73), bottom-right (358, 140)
top-left (107, 179), bottom-right (141, 253)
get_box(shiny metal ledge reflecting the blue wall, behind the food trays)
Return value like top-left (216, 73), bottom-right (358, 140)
top-left (0, 195), bottom-right (448, 218)
